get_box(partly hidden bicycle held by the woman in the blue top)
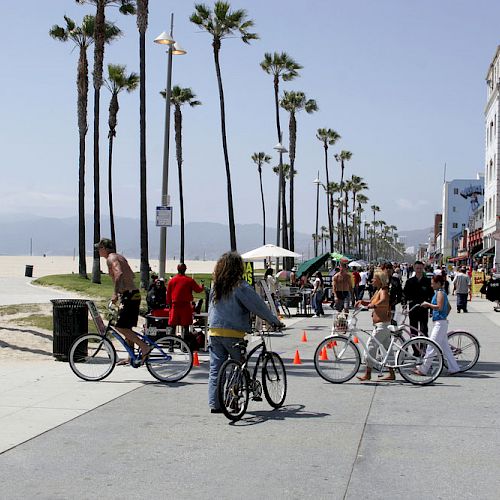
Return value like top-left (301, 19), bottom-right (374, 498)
top-left (398, 304), bottom-right (481, 372)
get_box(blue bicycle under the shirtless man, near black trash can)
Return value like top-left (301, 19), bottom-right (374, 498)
top-left (69, 301), bottom-right (193, 382)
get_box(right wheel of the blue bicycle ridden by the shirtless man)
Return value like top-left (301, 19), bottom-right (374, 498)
top-left (146, 335), bottom-right (193, 382)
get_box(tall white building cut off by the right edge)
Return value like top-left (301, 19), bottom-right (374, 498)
top-left (483, 46), bottom-right (500, 269)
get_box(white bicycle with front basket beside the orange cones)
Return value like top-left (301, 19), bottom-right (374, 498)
top-left (314, 308), bottom-right (444, 385)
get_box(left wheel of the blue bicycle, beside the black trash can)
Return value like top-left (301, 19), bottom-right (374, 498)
top-left (69, 333), bottom-right (116, 381)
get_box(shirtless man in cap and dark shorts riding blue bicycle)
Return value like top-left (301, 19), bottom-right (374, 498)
top-left (95, 238), bottom-right (152, 365)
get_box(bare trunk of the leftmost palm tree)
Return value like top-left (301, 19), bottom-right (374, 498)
top-left (77, 47), bottom-right (89, 278)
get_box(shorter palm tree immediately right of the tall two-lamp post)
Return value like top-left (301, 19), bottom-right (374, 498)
top-left (161, 85), bottom-right (201, 262)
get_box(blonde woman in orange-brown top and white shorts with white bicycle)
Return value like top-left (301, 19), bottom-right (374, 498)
top-left (356, 270), bottom-right (396, 382)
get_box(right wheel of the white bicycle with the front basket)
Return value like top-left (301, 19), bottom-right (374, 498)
top-left (397, 337), bottom-right (444, 385)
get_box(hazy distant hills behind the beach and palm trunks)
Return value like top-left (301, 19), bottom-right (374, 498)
top-left (0, 215), bottom-right (430, 260)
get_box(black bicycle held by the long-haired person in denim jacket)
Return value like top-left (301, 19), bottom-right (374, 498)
top-left (217, 331), bottom-right (287, 422)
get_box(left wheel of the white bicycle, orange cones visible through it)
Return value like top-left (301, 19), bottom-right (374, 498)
top-left (314, 336), bottom-right (361, 384)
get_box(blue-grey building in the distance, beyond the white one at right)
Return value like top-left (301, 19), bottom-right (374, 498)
top-left (442, 174), bottom-right (484, 262)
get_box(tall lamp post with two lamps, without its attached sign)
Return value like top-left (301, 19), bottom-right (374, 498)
top-left (154, 14), bottom-right (186, 278)
